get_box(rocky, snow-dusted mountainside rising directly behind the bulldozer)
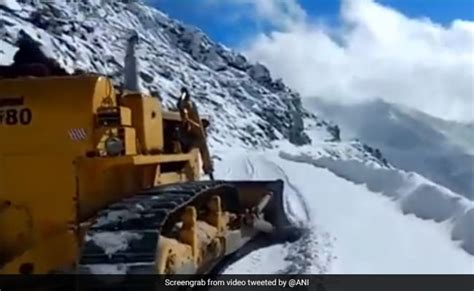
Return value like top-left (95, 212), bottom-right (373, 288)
top-left (0, 0), bottom-right (308, 147)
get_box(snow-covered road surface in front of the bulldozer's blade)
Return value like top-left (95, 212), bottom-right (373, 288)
top-left (218, 148), bottom-right (474, 274)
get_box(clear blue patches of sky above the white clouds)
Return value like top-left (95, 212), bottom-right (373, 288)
top-left (148, 0), bottom-right (474, 47)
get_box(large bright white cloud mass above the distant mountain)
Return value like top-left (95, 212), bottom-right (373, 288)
top-left (243, 0), bottom-right (474, 121)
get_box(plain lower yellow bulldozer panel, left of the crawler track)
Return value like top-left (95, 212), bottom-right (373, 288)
top-left (0, 155), bottom-right (76, 238)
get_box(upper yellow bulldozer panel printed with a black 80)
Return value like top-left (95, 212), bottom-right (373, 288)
top-left (0, 76), bottom-right (115, 159)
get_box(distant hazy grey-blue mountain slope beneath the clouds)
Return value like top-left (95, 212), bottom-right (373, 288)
top-left (304, 98), bottom-right (474, 200)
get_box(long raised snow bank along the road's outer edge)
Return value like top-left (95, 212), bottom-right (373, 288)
top-left (280, 147), bottom-right (474, 255)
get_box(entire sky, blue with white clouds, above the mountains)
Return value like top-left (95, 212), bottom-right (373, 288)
top-left (148, 0), bottom-right (474, 122)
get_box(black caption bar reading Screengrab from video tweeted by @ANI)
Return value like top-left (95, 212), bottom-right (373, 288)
top-left (0, 275), bottom-right (474, 291)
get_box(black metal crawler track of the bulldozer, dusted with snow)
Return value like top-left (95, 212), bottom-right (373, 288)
top-left (78, 181), bottom-right (238, 274)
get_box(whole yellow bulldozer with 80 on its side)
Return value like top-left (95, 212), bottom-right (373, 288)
top-left (0, 33), bottom-right (300, 274)
